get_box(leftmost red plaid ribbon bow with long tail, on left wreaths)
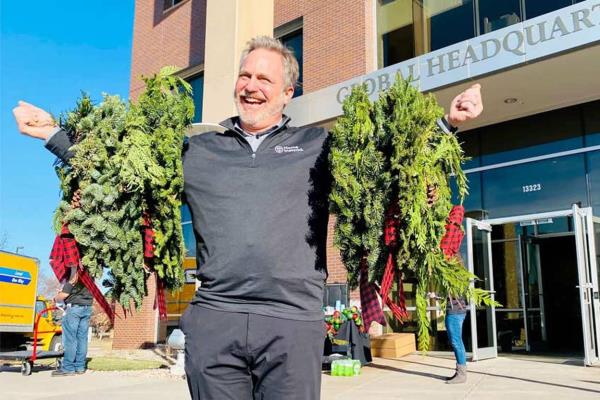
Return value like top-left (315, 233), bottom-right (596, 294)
top-left (50, 224), bottom-right (115, 321)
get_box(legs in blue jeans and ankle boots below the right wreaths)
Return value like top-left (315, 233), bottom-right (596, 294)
top-left (445, 297), bottom-right (467, 384)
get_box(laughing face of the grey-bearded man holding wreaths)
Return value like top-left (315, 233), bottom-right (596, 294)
top-left (235, 49), bottom-right (294, 133)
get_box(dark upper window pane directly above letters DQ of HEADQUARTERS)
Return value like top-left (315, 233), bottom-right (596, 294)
top-left (479, 0), bottom-right (523, 35)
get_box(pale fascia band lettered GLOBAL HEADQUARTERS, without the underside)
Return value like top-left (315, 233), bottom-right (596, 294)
top-left (286, 0), bottom-right (600, 125)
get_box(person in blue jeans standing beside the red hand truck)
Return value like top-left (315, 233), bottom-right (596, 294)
top-left (52, 270), bottom-right (93, 376)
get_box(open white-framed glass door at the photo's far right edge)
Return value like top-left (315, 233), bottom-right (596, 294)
top-left (573, 205), bottom-right (600, 365)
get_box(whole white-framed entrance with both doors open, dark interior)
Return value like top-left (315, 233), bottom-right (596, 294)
top-left (466, 205), bottom-right (600, 365)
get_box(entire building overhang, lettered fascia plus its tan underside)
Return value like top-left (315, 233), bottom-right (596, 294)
top-left (286, 0), bottom-right (600, 130)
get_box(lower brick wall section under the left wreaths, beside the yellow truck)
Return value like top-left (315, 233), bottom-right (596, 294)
top-left (112, 276), bottom-right (158, 350)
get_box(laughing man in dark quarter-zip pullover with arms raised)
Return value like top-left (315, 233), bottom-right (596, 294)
top-left (13, 37), bottom-right (483, 400)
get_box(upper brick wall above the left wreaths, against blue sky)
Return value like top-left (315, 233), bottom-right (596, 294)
top-left (129, 0), bottom-right (206, 98)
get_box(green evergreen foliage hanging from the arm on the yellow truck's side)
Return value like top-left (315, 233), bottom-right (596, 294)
top-left (54, 67), bottom-right (194, 307)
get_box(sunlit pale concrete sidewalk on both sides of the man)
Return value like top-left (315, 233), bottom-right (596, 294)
top-left (0, 354), bottom-right (600, 400)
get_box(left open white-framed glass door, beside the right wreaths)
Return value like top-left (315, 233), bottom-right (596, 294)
top-left (466, 218), bottom-right (498, 361)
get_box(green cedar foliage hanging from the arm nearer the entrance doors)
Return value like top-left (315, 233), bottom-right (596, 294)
top-left (330, 76), bottom-right (491, 350)
